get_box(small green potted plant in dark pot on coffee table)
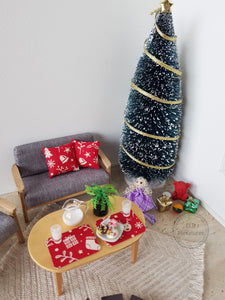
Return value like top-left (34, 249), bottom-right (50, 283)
top-left (85, 183), bottom-right (118, 217)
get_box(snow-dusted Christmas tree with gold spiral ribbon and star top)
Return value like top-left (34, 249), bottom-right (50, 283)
top-left (119, 0), bottom-right (182, 182)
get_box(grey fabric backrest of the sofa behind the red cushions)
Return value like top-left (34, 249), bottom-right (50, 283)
top-left (13, 133), bottom-right (93, 177)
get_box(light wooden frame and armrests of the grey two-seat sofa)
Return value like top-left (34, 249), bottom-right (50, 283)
top-left (12, 149), bottom-right (111, 223)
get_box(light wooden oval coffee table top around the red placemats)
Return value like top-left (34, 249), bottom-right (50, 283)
top-left (28, 196), bottom-right (145, 273)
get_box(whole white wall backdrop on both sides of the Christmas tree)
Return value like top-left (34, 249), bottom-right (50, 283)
top-left (0, 0), bottom-right (225, 224)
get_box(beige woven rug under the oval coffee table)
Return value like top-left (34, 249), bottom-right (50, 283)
top-left (0, 206), bottom-right (204, 300)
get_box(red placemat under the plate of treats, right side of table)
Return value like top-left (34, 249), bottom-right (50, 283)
top-left (96, 210), bottom-right (145, 246)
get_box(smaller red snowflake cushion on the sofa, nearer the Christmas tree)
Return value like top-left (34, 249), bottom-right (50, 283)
top-left (72, 140), bottom-right (99, 169)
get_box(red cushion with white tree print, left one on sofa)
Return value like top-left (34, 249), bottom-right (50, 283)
top-left (42, 143), bottom-right (79, 178)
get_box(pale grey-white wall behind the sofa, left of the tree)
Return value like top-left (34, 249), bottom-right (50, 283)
top-left (0, 0), bottom-right (158, 194)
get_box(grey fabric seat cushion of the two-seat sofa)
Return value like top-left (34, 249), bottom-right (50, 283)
top-left (23, 168), bottom-right (109, 207)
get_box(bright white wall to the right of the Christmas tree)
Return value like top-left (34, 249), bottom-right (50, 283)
top-left (173, 0), bottom-right (225, 225)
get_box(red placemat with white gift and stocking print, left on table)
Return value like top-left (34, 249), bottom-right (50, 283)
top-left (46, 224), bottom-right (101, 268)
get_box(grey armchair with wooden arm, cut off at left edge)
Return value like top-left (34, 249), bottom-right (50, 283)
top-left (0, 198), bottom-right (24, 245)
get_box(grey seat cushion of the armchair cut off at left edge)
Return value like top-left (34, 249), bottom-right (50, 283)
top-left (0, 212), bottom-right (17, 244)
